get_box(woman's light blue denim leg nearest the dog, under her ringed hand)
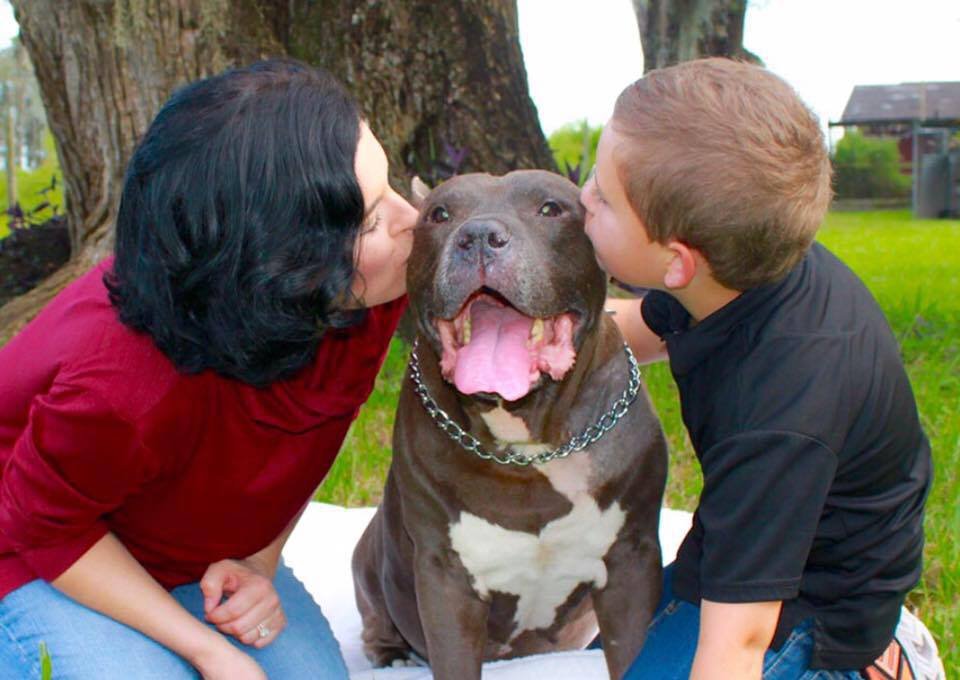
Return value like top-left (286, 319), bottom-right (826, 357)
top-left (172, 562), bottom-right (348, 680)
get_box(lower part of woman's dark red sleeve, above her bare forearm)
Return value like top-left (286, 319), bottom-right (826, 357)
top-left (0, 383), bottom-right (145, 581)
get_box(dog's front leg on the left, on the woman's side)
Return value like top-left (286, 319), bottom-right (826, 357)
top-left (416, 554), bottom-right (490, 680)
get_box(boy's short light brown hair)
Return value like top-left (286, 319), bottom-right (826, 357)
top-left (612, 59), bottom-right (831, 290)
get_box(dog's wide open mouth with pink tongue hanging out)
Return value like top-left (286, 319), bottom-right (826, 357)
top-left (434, 287), bottom-right (578, 401)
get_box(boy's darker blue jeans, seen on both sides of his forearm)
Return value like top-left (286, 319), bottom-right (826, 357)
top-left (624, 565), bottom-right (861, 680)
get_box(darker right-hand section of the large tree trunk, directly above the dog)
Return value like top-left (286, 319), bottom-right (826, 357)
top-left (289, 0), bottom-right (556, 189)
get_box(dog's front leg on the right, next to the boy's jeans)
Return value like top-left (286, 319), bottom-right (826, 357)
top-left (592, 538), bottom-right (663, 680)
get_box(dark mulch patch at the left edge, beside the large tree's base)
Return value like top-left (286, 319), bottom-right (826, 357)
top-left (0, 216), bottom-right (70, 306)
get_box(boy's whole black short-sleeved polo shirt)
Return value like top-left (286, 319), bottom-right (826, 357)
top-left (642, 244), bottom-right (931, 669)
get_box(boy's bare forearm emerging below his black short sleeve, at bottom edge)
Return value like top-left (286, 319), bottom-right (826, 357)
top-left (690, 600), bottom-right (781, 680)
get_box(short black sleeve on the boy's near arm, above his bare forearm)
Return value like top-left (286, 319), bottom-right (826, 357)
top-left (697, 431), bottom-right (837, 602)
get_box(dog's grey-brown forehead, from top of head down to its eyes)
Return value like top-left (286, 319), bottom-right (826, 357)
top-left (421, 170), bottom-right (583, 223)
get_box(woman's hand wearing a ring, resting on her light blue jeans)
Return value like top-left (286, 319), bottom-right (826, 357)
top-left (200, 557), bottom-right (287, 648)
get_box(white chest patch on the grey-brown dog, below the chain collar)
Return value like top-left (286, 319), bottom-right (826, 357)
top-left (450, 452), bottom-right (626, 639)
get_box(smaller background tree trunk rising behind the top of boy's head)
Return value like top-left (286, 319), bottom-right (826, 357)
top-left (633, 0), bottom-right (761, 72)
